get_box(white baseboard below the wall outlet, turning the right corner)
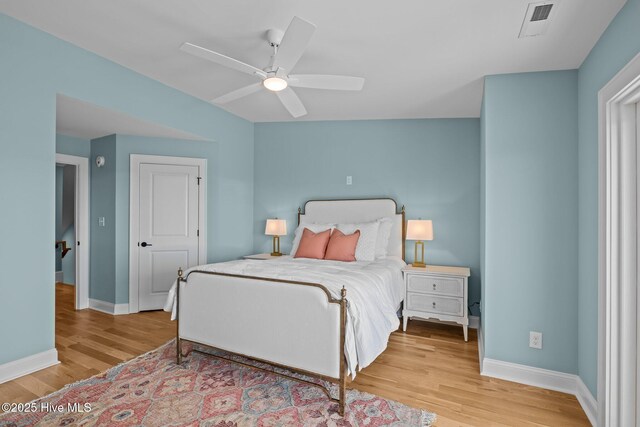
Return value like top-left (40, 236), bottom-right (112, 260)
top-left (480, 357), bottom-right (598, 426)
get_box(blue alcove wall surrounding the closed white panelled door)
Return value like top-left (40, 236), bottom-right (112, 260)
top-left (90, 135), bottom-right (224, 304)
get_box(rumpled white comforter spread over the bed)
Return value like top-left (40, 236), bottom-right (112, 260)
top-left (164, 256), bottom-right (405, 377)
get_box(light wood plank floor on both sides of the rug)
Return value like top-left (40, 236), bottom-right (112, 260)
top-left (0, 285), bottom-right (589, 426)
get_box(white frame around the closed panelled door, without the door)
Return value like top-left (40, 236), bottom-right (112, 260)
top-left (129, 154), bottom-right (207, 313)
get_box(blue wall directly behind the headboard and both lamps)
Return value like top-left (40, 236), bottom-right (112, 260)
top-left (253, 119), bottom-right (480, 313)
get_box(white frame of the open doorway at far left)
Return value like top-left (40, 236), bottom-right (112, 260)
top-left (56, 153), bottom-right (90, 310)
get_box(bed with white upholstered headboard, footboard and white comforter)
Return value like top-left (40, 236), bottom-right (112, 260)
top-left (165, 199), bottom-right (405, 415)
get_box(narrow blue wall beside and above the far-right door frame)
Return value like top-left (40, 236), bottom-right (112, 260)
top-left (578, 0), bottom-right (640, 396)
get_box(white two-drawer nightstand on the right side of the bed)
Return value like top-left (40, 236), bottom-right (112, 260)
top-left (402, 265), bottom-right (471, 341)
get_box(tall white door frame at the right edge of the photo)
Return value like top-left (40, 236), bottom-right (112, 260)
top-left (598, 54), bottom-right (640, 427)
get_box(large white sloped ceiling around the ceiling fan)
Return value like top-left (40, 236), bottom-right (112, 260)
top-left (0, 0), bottom-right (625, 122)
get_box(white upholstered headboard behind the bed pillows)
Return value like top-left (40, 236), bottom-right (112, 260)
top-left (298, 199), bottom-right (404, 259)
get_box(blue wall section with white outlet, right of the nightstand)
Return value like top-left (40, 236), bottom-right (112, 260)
top-left (482, 70), bottom-right (578, 373)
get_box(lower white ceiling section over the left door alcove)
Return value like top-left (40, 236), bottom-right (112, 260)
top-left (56, 95), bottom-right (204, 140)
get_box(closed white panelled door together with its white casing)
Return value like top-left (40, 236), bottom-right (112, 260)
top-left (129, 155), bottom-right (206, 312)
